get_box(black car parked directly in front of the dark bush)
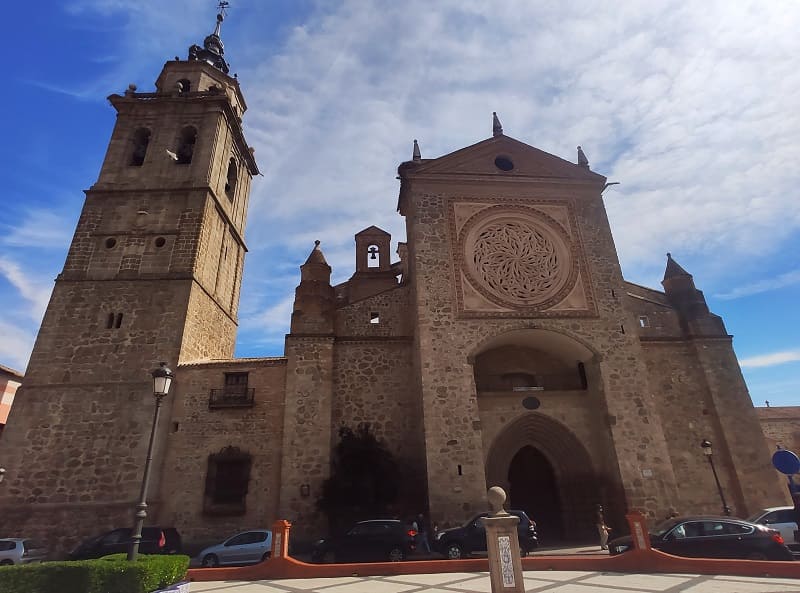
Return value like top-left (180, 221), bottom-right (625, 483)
top-left (311, 519), bottom-right (417, 562)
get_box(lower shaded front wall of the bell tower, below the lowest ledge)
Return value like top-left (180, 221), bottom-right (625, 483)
top-left (0, 280), bottom-right (194, 549)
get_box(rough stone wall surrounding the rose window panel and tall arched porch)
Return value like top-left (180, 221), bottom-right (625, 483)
top-left (406, 182), bottom-right (675, 517)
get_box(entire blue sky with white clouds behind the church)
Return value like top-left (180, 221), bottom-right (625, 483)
top-left (0, 0), bottom-right (800, 405)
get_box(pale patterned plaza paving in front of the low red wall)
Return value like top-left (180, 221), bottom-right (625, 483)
top-left (190, 571), bottom-right (800, 593)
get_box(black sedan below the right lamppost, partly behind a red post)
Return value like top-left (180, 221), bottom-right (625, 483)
top-left (608, 516), bottom-right (793, 560)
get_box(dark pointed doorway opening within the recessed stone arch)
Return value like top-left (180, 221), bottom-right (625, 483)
top-left (508, 445), bottom-right (566, 542)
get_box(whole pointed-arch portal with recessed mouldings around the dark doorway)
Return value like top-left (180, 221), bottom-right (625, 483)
top-left (486, 412), bottom-right (602, 545)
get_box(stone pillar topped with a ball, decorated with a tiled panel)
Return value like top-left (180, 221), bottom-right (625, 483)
top-left (483, 486), bottom-right (525, 593)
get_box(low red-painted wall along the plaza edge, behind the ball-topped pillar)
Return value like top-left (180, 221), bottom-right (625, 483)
top-left (188, 550), bottom-right (800, 581)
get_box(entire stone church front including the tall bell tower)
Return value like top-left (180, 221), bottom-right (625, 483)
top-left (0, 20), bottom-right (787, 550)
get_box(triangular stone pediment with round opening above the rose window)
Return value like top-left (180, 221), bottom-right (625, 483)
top-left (409, 135), bottom-right (605, 182)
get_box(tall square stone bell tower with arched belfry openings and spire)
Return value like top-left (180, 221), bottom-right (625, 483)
top-left (0, 9), bottom-right (258, 550)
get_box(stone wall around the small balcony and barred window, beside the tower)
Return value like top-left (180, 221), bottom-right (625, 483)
top-left (158, 358), bottom-right (286, 544)
